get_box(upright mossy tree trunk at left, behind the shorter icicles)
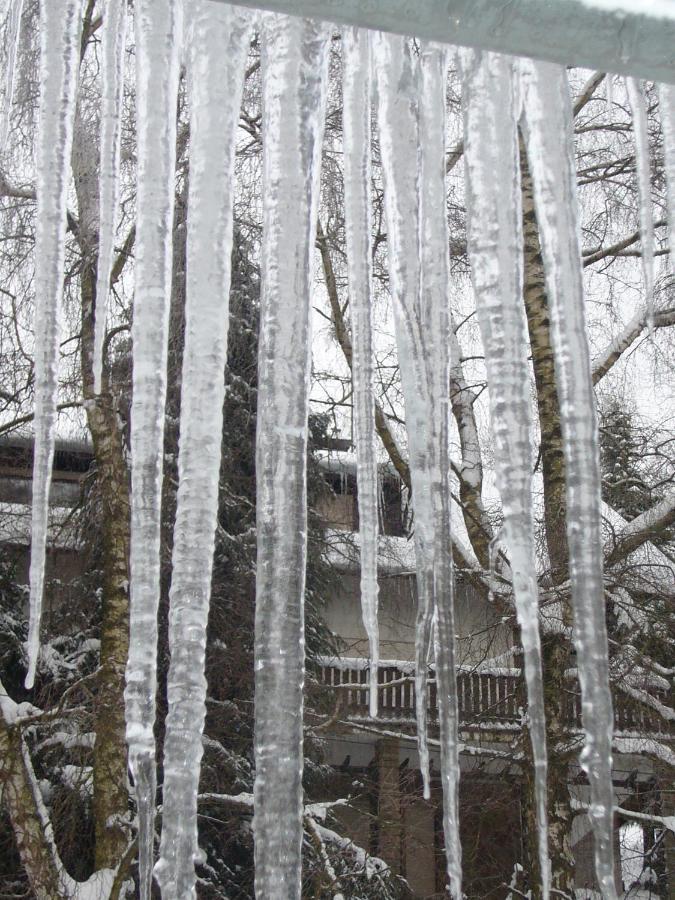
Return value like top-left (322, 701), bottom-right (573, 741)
top-left (72, 102), bottom-right (130, 869)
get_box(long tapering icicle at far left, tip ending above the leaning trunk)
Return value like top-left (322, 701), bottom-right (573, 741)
top-left (26, 0), bottom-right (80, 689)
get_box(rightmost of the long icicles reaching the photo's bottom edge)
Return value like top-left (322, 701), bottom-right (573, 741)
top-left (521, 61), bottom-right (616, 900)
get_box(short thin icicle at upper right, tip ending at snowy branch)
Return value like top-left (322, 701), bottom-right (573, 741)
top-left (626, 78), bottom-right (654, 333)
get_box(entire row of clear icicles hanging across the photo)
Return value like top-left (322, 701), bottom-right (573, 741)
top-left (17, 0), bottom-right (675, 900)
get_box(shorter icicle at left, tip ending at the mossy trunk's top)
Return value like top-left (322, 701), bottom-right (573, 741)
top-left (94, 0), bottom-right (127, 394)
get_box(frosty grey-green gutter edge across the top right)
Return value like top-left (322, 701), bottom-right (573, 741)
top-left (228, 0), bottom-right (675, 83)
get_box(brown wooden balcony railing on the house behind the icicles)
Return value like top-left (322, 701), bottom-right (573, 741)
top-left (320, 659), bottom-right (675, 738)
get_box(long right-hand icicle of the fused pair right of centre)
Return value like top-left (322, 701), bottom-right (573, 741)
top-left (413, 42), bottom-right (463, 898)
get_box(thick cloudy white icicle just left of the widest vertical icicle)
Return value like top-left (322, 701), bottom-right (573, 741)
top-left (155, 0), bottom-right (252, 898)
